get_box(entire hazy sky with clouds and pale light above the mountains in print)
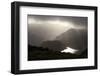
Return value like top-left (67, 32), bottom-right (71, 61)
top-left (28, 15), bottom-right (87, 45)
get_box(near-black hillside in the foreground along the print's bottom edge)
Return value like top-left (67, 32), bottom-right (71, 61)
top-left (28, 45), bottom-right (87, 61)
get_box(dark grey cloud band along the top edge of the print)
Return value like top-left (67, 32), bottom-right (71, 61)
top-left (28, 15), bottom-right (88, 26)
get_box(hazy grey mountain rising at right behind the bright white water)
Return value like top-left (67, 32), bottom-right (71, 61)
top-left (56, 29), bottom-right (87, 53)
